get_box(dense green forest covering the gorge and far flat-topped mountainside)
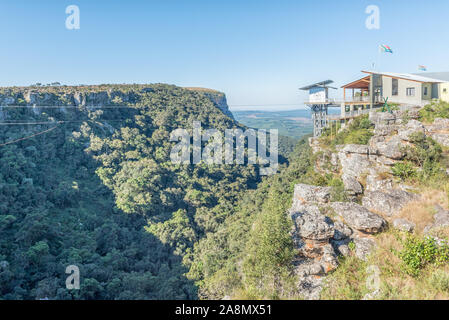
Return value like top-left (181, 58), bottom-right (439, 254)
top-left (0, 84), bottom-right (301, 299)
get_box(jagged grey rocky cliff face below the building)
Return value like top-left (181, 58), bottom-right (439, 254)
top-left (289, 108), bottom-right (449, 299)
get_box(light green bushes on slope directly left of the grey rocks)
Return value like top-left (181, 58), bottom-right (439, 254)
top-left (189, 140), bottom-right (313, 299)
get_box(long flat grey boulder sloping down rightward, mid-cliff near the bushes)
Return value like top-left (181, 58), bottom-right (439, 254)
top-left (330, 202), bottom-right (387, 233)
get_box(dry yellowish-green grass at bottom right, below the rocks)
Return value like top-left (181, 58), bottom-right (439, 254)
top-left (321, 230), bottom-right (449, 300)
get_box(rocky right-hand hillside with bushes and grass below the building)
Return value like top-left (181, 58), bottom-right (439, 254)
top-left (197, 102), bottom-right (449, 299)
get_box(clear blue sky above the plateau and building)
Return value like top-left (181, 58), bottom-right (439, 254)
top-left (0, 0), bottom-right (449, 110)
